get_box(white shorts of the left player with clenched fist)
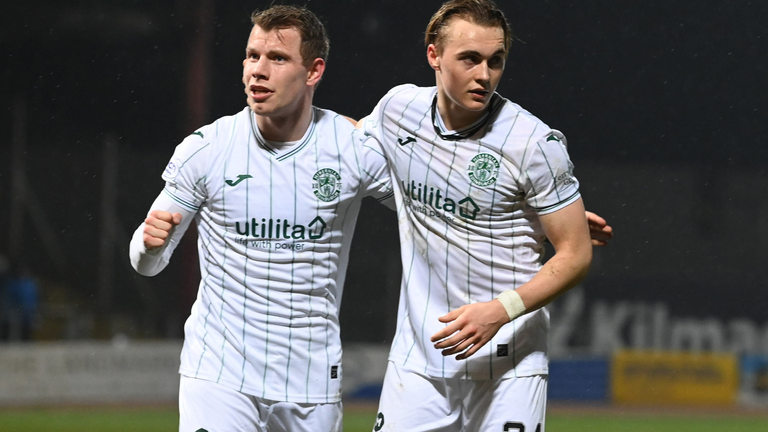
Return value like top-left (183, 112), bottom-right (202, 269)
top-left (179, 375), bottom-right (342, 432)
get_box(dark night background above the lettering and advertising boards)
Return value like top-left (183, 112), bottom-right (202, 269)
top-left (0, 0), bottom-right (768, 342)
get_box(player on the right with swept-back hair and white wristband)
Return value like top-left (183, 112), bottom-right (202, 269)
top-left (360, 0), bottom-right (610, 432)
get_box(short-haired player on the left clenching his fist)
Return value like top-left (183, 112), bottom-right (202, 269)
top-left (130, 6), bottom-right (391, 432)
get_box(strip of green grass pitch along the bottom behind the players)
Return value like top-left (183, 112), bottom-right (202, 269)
top-left (0, 405), bottom-right (768, 432)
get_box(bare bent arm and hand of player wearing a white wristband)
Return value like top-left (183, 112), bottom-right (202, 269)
top-left (431, 198), bottom-right (592, 360)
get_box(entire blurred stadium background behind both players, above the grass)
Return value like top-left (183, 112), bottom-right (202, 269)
top-left (0, 0), bottom-right (768, 430)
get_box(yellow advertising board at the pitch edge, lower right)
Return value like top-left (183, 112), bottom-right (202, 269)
top-left (611, 351), bottom-right (739, 405)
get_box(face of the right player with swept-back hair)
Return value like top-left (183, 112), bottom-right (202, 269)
top-left (427, 18), bottom-right (505, 121)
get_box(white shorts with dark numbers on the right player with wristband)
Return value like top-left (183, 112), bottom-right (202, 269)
top-left (373, 361), bottom-right (547, 432)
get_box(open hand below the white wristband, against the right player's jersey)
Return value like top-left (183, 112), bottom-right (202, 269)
top-left (430, 300), bottom-right (509, 360)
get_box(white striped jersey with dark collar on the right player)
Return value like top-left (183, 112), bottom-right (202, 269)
top-left (363, 85), bottom-right (580, 379)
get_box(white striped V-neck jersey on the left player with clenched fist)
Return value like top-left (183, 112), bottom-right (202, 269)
top-left (132, 108), bottom-right (392, 403)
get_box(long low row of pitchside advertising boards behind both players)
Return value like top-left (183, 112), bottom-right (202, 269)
top-left (0, 340), bottom-right (768, 407)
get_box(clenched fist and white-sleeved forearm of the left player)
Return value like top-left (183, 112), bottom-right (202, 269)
top-left (130, 192), bottom-right (195, 276)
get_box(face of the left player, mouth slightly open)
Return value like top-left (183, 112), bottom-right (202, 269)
top-left (243, 26), bottom-right (322, 117)
